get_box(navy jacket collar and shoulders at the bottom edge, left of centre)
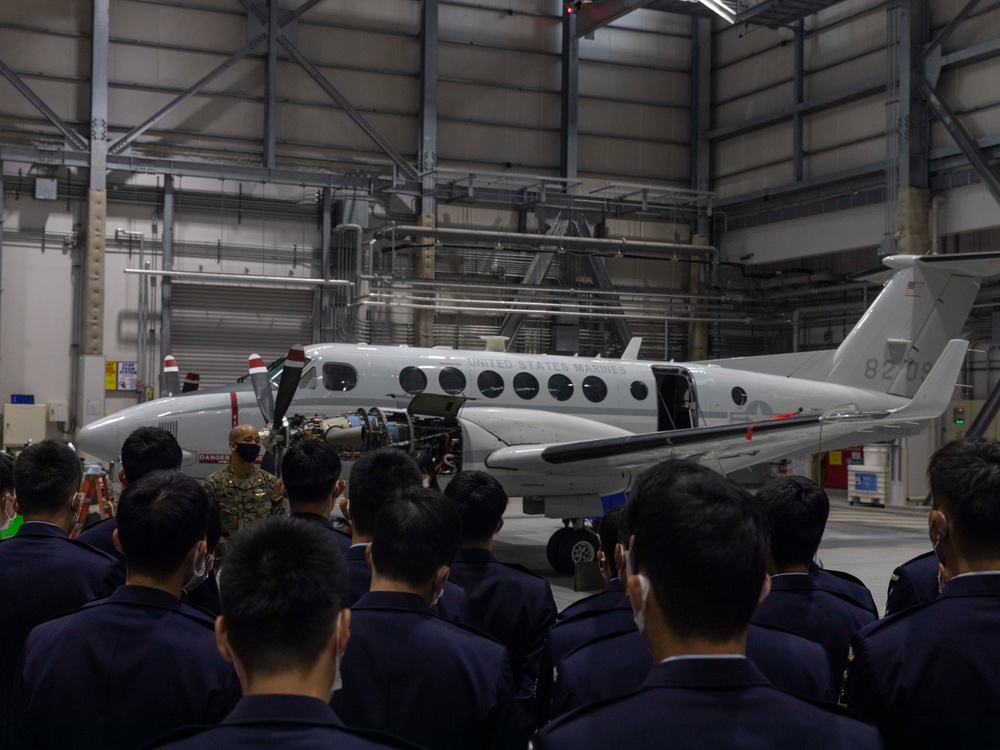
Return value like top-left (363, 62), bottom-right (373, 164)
top-left (147, 695), bottom-right (418, 750)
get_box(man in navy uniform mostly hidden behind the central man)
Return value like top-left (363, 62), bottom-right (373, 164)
top-left (340, 448), bottom-right (465, 622)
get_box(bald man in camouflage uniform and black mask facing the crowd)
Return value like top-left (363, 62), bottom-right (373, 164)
top-left (205, 424), bottom-right (288, 563)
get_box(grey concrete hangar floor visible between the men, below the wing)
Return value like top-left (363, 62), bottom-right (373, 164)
top-left (493, 492), bottom-right (931, 613)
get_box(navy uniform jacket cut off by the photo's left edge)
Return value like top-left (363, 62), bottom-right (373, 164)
top-left (0, 521), bottom-right (125, 724)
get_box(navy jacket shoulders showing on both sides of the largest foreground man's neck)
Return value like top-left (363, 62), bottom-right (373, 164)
top-left (552, 625), bottom-right (836, 716)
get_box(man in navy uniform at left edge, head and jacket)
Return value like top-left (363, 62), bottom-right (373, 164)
top-left (0, 440), bottom-right (125, 736)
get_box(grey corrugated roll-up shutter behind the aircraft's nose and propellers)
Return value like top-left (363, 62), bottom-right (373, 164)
top-left (171, 281), bottom-right (315, 386)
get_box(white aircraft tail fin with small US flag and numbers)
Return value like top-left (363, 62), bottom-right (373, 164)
top-left (827, 253), bottom-right (1000, 398)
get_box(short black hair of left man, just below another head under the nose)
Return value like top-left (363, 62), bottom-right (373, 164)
top-left (117, 471), bottom-right (209, 575)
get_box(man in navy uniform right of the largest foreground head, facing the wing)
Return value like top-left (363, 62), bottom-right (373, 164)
top-left (752, 477), bottom-right (876, 681)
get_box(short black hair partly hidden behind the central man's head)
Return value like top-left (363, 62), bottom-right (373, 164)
top-left (347, 448), bottom-right (424, 535)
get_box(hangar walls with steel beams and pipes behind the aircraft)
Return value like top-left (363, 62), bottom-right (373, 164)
top-left (0, 0), bottom-right (1000, 506)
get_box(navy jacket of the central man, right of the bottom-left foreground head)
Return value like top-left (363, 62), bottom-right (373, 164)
top-left (330, 591), bottom-right (515, 750)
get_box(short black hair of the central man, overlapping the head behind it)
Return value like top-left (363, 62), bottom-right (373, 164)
top-left (372, 487), bottom-right (462, 586)
